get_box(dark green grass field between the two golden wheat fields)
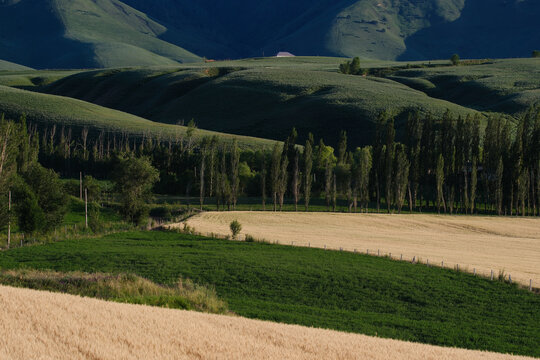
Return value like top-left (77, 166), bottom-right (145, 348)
top-left (0, 232), bottom-right (540, 356)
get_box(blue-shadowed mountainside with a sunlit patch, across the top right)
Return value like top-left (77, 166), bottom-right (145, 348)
top-left (124, 0), bottom-right (540, 60)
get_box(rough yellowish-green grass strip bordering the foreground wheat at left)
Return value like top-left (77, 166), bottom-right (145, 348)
top-left (0, 270), bottom-right (227, 314)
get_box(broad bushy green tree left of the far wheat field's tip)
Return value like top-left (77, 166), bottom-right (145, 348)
top-left (114, 156), bottom-right (159, 225)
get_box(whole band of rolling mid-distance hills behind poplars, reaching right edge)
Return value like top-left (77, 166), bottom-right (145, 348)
top-left (34, 57), bottom-right (540, 144)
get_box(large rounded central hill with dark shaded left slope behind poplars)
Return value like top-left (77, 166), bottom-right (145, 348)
top-left (35, 58), bottom-right (484, 145)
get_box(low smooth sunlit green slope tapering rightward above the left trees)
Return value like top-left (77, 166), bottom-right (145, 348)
top-left (0, 85), bottom-right (274, 148)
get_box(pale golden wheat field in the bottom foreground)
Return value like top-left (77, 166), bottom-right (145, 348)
top-left (0, 286), bottom-right (525, 360)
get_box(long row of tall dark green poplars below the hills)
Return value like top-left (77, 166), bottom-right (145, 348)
top-left (15, 109), bottom-right (540, 215)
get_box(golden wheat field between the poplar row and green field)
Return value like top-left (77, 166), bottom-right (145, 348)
top-left (181, 212), bottom-right (540, 287)
